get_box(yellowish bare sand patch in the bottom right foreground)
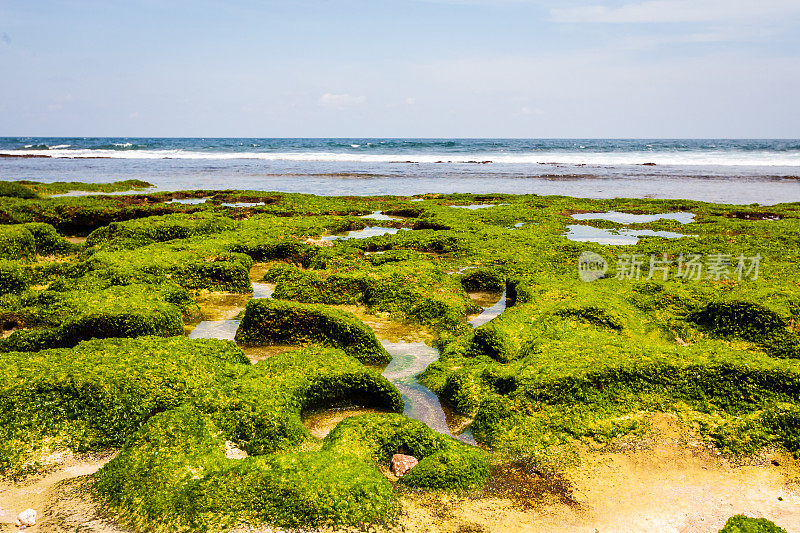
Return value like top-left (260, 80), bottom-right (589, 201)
top-left (401, 414), bottom-right (800, 533)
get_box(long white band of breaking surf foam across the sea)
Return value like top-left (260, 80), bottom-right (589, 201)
top-left (0, 145), bottom-right (800, 167)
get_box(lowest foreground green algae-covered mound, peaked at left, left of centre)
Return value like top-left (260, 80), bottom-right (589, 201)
top-left (95, 406), bottom-right (400, 531)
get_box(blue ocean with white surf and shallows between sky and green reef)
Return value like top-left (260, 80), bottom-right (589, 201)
top-left (0, 137), bottom-right (800, 205)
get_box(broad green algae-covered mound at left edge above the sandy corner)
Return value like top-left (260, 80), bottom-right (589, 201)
top-left (0, 337), bottom-right (248, 473)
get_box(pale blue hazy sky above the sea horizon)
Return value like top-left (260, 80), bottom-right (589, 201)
top-left (0, 0), bottom-right (800, 138)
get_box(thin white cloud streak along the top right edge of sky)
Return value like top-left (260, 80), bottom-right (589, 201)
top-left (550, 0), bottom-right (800, 24)
